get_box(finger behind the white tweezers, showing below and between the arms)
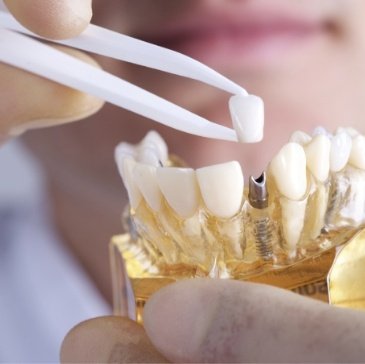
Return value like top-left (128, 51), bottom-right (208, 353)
top-left (0, 46), bottom-right (103, 138)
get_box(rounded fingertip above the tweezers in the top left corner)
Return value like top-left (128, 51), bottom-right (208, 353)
top-left (4, 0), bottom-right (92, 39)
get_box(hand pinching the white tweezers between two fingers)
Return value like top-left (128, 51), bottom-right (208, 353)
top-left (0, 0), bottom-right (103, 144)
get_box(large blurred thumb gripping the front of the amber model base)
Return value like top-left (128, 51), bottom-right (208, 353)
top-left (144, 279), bottom-right (365, 362)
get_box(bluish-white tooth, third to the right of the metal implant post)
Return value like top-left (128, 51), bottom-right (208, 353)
top-left (330, 131), bottom-right (352, 172)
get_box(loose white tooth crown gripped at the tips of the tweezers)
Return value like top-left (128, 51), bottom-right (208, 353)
top-left (229, 95), bottom-right (264, 143)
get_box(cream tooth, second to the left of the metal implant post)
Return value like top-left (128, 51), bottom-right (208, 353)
top-left (156, 167), bottom-right (199, 218)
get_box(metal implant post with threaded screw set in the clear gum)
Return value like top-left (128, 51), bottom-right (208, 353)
top-left (248, 172), bottom-right (274, 261)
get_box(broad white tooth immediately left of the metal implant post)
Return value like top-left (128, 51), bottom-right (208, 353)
top-left (196, 161), bottom-right (244, 218)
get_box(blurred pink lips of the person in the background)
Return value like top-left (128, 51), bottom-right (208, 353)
top-left (142, 11), bottom-right (326, 67)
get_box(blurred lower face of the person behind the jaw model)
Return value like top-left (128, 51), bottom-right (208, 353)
top-left (24, 0), bottom-right (365, 191)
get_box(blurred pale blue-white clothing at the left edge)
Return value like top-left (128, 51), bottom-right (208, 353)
top-left (0, 142), bottom-right (111, 363)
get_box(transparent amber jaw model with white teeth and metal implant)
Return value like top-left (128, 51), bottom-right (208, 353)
top-left (111, 128), bottom-right (365, 321)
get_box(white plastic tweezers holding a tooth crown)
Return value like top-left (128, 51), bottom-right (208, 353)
top-left (0, 11), bottom-right (247, 141)
